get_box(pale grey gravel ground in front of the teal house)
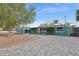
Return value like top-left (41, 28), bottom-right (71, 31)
top-left (0, 35), bottom-right (79, 56)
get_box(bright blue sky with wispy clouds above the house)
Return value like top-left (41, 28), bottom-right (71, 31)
top-left (28, 3), bottom-right (79, 26)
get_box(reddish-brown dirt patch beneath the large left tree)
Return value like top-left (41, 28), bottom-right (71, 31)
top-left (0, 33), bottom-right (39, 48)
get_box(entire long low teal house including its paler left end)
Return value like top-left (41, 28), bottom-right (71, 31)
top-left (16, 25), bottom-right (72, 36)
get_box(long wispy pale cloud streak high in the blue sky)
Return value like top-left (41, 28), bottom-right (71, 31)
top-left (38, 6), bottom-right (69, 14)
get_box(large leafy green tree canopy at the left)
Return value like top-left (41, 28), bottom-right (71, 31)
top-left (0, 3), bottom-right (36, 30)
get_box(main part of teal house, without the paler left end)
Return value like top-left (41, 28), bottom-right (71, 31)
top-left (29, 26), bottom-right (71, 36)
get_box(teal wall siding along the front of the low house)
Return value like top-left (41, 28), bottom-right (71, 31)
top-left (16, 27), bottom-right (71, 36)
